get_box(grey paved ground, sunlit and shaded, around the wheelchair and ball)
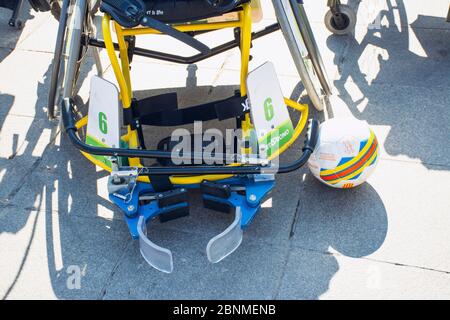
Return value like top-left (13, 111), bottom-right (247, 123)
top-left (0, 0), bottom-right (450, 299)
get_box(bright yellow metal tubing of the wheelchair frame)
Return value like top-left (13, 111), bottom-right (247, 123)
top-left (76, 4), bottom-right (308, 185)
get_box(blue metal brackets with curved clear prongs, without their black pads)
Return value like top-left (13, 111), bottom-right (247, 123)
top-left (109, 175), bottom-right (275, 273)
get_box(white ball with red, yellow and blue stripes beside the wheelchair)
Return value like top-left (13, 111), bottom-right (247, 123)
top-left (308, 118), bottom-right (379, 188)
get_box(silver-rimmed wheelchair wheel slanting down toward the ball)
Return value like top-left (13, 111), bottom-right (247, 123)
top-left (272, 0), bottom-right (331, 111)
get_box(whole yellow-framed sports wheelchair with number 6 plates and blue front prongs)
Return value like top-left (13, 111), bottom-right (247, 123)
top-left (48, 0), bottom-right (331, 273)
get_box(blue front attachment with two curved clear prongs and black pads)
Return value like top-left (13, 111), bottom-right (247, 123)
top-left (110, 176), bottom-right (275, 273)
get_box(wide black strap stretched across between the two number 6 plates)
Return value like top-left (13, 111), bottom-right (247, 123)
top-left (138, 96), bottom-right (248, 126)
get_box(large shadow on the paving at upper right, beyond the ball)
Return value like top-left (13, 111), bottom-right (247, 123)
top-left (327, 0), bottom-right (450, 170)
